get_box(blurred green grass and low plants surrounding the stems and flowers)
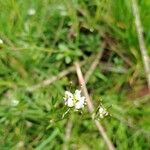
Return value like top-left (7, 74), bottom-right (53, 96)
top-left (0, 0), bottom-right (150, 150)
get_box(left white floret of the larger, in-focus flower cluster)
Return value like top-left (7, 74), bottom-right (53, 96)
top-left (64, 91), bottom-right (74, 107)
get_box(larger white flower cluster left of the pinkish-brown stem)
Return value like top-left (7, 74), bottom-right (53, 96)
top-left (63, 90), bottom-right (86, 110)
